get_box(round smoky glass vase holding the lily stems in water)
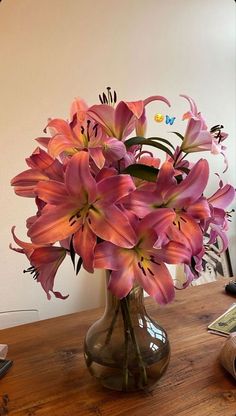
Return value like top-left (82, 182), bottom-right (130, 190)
top-left (84, 278), bottom-right (170, 391)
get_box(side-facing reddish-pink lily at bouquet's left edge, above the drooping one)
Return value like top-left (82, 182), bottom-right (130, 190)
top-left (11, 147), bottom-right (64, 198)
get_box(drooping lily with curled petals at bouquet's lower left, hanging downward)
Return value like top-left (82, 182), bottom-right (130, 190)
top-left (10, 227), bottom-right (68, 299)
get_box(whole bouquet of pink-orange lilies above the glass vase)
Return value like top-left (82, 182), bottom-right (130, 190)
top-left (11, 88), bottom-right (235, 304)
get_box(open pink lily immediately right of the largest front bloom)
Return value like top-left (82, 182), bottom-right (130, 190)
top-left (121, 159), bottom-right (211, 255)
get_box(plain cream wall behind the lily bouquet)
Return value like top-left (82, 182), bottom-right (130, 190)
top-left (0, 0), bottom-right (236, 318)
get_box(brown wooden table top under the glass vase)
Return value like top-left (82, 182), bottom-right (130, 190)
top-left (0, 281), bottom-right (236, 416)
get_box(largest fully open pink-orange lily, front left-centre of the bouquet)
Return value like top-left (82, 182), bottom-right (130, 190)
top-left (28, 151), bottom-right (135, 272)
